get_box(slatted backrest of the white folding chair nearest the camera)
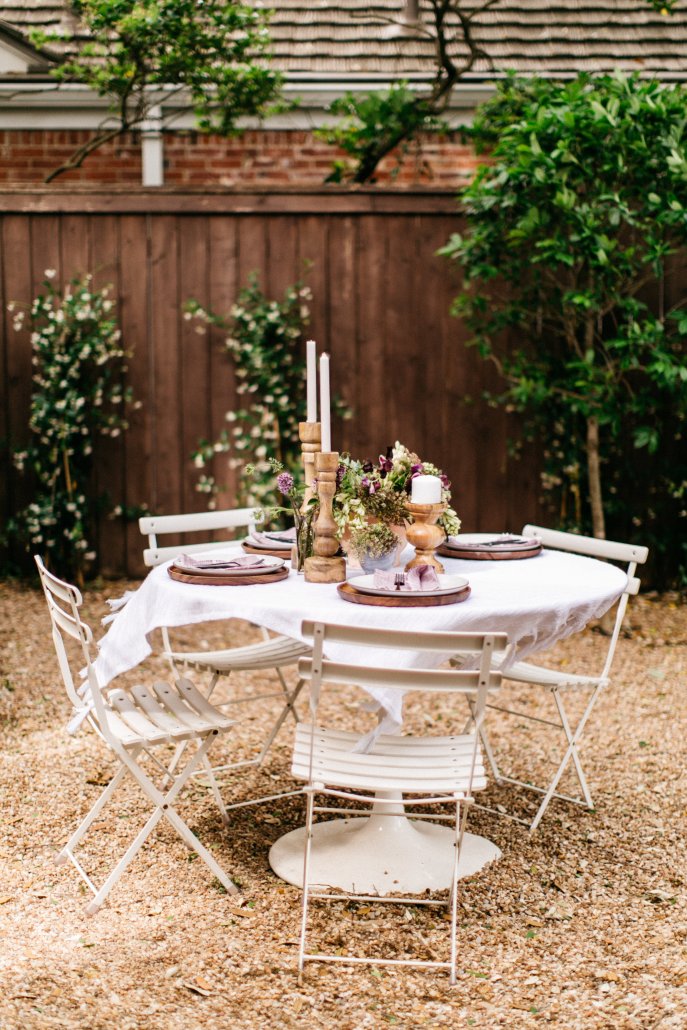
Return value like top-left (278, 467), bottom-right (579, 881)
top-left (299, 621), bottom-right (508, 718)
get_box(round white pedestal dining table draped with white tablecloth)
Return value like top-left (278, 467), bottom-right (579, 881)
top-left (95, 545), bottom-right (627, 896)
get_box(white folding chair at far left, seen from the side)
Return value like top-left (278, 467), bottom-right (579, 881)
top-left (35, 555), bottom-right (237, 916)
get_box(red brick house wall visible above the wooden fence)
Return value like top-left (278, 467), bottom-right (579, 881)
top-left (0, 130), bottom-right (484, 188)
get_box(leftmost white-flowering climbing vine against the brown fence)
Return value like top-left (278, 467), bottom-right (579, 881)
top-left (6, 269), bottom-right (132, 581)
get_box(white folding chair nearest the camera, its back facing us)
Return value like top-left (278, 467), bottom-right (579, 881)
top-left (293, 622), bottom-right (508, 984)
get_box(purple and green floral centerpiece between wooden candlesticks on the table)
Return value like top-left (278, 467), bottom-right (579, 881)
top-left (334, 440), bottom-right (460, 539)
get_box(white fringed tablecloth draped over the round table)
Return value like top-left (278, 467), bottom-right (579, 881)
top-left (95, 551), bottom-right (627, 729)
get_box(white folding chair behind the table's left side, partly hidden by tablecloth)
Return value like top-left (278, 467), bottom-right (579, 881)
top-left (138, 508), bottom-right (310, 778)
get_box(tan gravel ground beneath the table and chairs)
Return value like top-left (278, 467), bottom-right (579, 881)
top-left (0, 583), bottom-right (687, 1030)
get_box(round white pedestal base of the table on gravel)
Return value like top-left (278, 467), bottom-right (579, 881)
top-left (270, 815), bottom-right (501, 896)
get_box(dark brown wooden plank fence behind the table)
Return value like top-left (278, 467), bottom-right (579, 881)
top-left (0, 190), bottom-right (539, 575)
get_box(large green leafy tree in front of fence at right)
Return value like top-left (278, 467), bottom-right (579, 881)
top-left (442, 74), bottom-right (687, 580)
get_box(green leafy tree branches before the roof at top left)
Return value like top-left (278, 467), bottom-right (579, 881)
top-left (32, 0), bottom-right (280, 181)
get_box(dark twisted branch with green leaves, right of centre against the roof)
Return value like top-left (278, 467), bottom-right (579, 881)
top-left (317, 0), bottom-right (677, 183)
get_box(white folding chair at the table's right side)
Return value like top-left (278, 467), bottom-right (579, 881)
top-left (469, 525), bottom-right (649, 832)
